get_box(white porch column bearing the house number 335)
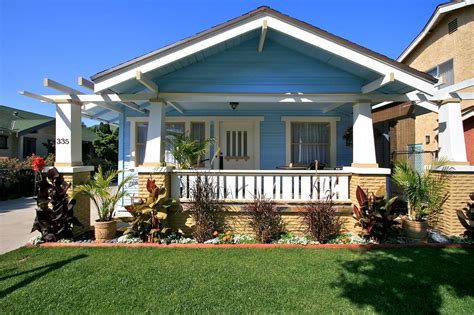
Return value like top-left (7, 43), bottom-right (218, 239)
top-left (54, 103), bottom-right (82, 166)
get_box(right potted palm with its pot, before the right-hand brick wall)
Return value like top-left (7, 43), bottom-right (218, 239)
top-left (393, 160), bottom-right (449, 239)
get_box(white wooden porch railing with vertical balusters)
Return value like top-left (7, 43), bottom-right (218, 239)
top-left (171, 170), bottom-right (351, 201)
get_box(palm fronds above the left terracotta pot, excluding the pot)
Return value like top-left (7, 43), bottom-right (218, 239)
top-left (72, 166), bottom-right (133, 222)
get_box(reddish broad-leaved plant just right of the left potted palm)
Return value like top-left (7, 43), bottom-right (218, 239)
top-left (124, 178), bottom-right (176, 243)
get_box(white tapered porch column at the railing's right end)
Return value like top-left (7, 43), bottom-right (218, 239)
top-left (352, 102), bottom-right (378, 167)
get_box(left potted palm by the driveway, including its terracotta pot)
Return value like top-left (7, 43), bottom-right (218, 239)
top-left (73, 166), bottom-right (133, 242)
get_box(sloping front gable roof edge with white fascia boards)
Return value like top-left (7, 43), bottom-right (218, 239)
top-left (91, 6), bottom-right (437, 92)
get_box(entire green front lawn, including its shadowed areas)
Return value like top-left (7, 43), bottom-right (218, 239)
top-left (0, 248), bottom-right (474, 314)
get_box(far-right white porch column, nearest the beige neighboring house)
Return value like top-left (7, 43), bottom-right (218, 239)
top-left (438, 99), bottom-right (468, 165)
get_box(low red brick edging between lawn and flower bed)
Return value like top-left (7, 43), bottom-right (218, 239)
top-left (34, 243), bottom-right (474, 249)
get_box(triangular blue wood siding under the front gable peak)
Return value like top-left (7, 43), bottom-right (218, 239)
top-left (155, 38), bottom-right (366, 93)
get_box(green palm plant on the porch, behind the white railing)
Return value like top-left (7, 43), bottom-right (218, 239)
top-left (169, 134), bottom-right (213, 169)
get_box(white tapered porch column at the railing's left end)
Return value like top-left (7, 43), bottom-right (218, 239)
top-left (143, 102), bottom-right (166, 166)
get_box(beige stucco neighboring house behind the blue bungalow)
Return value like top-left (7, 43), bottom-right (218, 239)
top-left (374, 0), bottom-right (474, 165)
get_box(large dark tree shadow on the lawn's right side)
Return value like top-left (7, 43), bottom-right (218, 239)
top-left (335, 249), bottom-right (474, 314)
